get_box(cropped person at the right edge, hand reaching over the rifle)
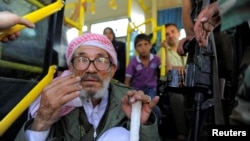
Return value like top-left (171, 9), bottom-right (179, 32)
top-left (194, 0), bottom-right (250, 125)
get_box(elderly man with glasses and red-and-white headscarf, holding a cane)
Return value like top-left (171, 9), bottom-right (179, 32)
top-left (16, 33), bottom-right (159, 141)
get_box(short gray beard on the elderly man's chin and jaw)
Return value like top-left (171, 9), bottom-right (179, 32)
top-left (80, 78), bottom-right (110, 100)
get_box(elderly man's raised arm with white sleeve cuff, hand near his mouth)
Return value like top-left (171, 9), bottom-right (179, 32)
top-left (16, 75), bottom-right (82, 141)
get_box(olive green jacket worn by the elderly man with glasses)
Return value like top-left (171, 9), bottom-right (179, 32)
top-left (15, 83), bottom-right (160, 141)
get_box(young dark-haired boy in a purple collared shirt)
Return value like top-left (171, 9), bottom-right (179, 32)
top-left (124, 34), bottom-right (160, 98)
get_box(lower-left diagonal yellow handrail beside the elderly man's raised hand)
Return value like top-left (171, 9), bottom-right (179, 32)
top-left (0, 65), bottom-right (56, 137)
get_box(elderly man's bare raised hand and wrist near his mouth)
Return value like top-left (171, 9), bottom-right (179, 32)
top-left (30, 75), bottom-right (82, 131)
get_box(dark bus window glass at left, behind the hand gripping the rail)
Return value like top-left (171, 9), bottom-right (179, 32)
top-left (0, 0), bottom-right (50, 80)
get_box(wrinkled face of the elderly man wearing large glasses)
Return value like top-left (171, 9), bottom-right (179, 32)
top-left (69, 46), bottom-right (116, 98)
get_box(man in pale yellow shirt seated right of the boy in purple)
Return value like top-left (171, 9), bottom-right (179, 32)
top-left (162, 23), bottom-right (188, 140)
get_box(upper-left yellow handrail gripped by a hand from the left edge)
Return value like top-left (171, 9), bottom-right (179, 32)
top-left (0, 0), bottom-right (64, 40)
